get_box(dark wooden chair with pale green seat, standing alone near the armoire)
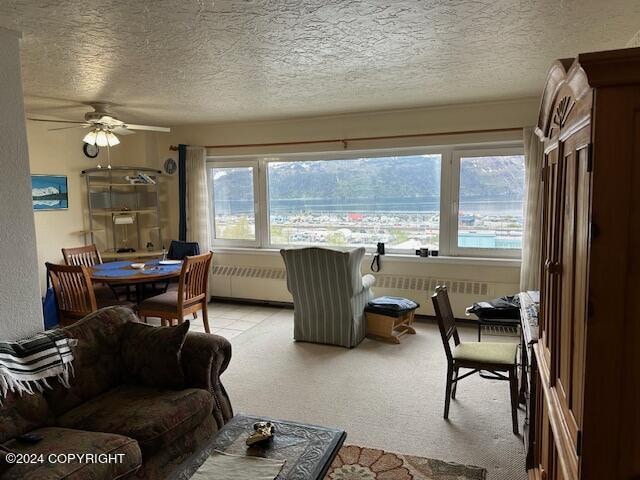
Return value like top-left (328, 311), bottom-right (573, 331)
top-left (431, 286), bottom-right (518, 435)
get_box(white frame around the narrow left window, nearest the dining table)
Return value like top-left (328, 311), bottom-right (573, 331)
top-left (206, 159), bottom-right (263, 248)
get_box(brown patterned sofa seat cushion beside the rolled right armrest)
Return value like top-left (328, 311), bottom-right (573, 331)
top-left (58, 385), bottom-right (213, 458)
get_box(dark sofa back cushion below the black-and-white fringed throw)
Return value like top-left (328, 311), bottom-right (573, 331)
top-left (0, 392), bottom-right (53, 443)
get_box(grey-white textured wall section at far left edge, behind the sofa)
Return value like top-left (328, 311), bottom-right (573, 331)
top-left (0, 28), bottom-right (42, 340)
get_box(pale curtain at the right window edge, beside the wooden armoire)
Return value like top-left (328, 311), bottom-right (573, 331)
top-left (520, 128), bottom-right (544, 291)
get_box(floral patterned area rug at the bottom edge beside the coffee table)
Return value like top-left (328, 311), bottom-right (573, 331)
top-left (325, 445), bottom-right (487, 480)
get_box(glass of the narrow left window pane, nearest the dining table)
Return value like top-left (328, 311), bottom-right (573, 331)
top-left (209, 163), bottom-right (257, 246)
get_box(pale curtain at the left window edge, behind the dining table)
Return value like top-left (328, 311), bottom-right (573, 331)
top-left (185, 147), bottom-right (213, 296)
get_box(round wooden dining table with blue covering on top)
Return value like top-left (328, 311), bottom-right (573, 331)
top-left (91, 259), bottom-right (182, 304)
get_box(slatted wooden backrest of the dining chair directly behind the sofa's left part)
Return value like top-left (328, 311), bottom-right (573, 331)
top-left (46, 262), bottom-right (98, 323)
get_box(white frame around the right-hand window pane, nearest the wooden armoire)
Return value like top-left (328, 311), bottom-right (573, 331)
top-left (440, 146), bottom-right (526, 258)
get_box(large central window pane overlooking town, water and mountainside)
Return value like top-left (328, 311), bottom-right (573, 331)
top-left (267, 155), bottom-right (441, 250)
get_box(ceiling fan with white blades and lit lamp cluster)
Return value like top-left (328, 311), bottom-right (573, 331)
top-left (29, 102), bottom-right (171, 147)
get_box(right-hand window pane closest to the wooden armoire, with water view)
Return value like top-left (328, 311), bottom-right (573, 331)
top-left (451, 152), bottom-right (524, 256)
